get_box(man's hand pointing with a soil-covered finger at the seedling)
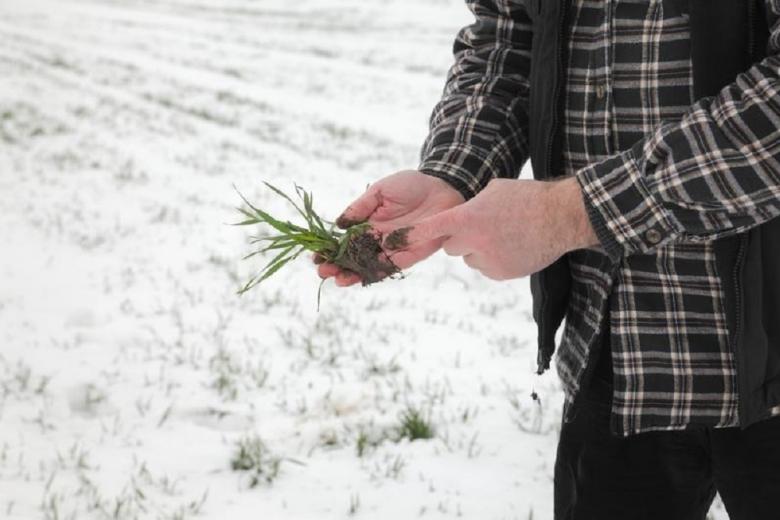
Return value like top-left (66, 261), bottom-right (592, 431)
top-left (384, 177), bottom-right (599, 280)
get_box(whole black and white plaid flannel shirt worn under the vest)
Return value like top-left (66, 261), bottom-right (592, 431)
top-left (419, 0), bottom-right (780, 435)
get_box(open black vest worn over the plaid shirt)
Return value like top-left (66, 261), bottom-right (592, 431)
top-left (526, 0), bottom-right (780, 428)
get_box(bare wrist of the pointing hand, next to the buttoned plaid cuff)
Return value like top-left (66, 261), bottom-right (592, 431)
top-left (552, 176), bottom-right (600, 252)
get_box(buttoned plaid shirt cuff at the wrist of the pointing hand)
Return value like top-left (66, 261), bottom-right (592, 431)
top-left (575, 142), bottom-right (681, 262)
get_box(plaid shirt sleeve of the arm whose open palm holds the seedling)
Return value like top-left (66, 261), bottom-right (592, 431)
top-left (418, 0), bottom-right (532, 200)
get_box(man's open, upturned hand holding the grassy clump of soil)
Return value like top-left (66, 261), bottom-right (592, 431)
top-left (313, 170), bottom-right (464, 287)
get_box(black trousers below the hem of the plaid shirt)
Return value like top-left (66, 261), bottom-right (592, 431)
top-left (555, 372), bottom-right (780, 520)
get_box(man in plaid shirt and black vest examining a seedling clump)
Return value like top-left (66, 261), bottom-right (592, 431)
top-left (312, 0), bottom-right (780, 520)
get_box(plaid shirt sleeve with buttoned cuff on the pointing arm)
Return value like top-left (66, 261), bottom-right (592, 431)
top-left (575, 0), bottom-right (780, 260)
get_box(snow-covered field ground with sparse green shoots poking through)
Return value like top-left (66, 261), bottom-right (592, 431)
top-left (0, 0), bottom-right (728, 520)
